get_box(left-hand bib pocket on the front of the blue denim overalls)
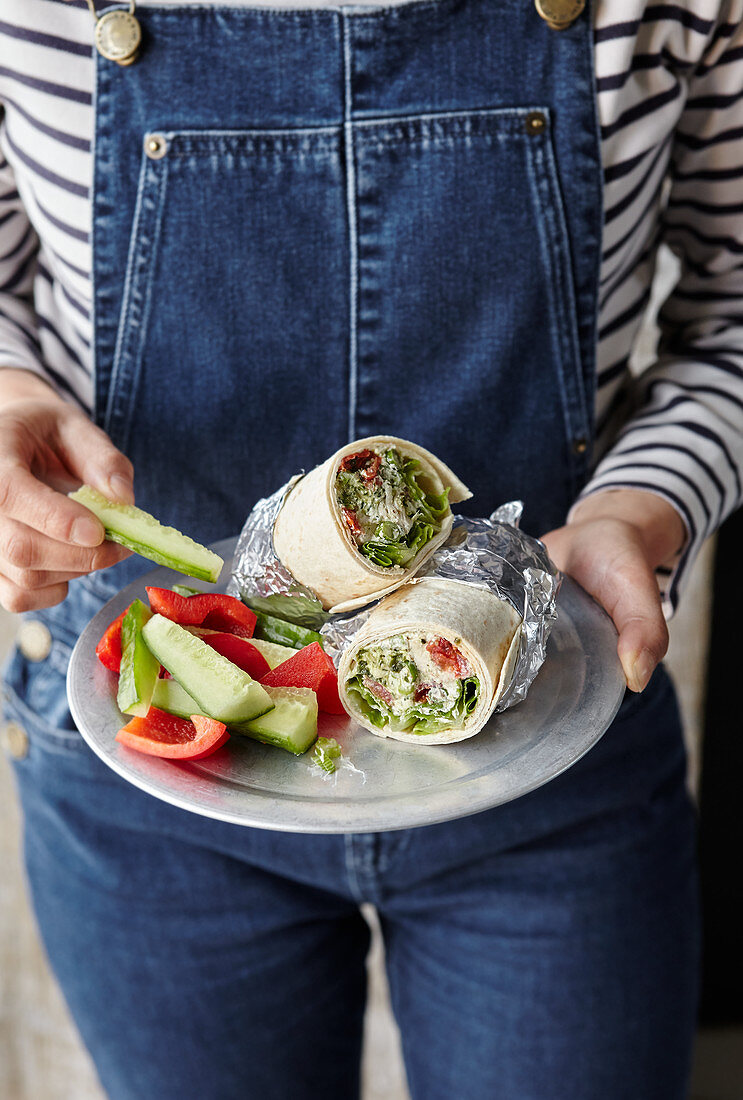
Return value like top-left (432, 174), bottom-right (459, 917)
top-left (105, 127), bottom-right (349, 541)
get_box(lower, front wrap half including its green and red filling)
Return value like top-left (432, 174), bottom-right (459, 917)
top-left (338, 578), bottom-right (522, 745)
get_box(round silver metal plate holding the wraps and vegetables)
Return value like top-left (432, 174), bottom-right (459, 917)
top-left (67, 539), bottom-right (624, 833)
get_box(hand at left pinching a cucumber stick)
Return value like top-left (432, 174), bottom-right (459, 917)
top-left (0, 369), bottom-right (134, 612)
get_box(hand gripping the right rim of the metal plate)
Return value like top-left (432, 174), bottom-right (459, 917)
top-left (543, 490), bottom-right (686, 692)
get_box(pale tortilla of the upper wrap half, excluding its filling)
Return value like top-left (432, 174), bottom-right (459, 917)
top-left (273, 436), bottom-right (472, 613)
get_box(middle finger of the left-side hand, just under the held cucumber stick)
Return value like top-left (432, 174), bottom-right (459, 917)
top-left (0, 516), bottom-right (131, 584)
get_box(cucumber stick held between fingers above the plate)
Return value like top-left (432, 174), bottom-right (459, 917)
top-left (69, 485), bottom-right (225, 581)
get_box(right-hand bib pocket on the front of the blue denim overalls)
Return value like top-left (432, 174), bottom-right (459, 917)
top-left (353, 106), bottom-right (589, 529)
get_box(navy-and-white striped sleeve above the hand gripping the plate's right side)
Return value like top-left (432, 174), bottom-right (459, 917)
top-left (581, 3), bottom-right (743, 615)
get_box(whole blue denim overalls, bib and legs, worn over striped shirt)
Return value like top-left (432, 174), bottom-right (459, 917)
top-left (6, 0), bottom-right (696, 1100)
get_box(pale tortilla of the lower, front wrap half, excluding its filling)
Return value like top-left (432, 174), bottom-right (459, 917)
top-left (338, 578), bottom-right (522, 745)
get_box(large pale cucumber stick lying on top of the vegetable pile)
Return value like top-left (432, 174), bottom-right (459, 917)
top-left (142, 615), bottom-right (273, 725)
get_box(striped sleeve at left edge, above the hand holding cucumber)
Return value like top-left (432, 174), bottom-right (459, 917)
top-left (0, 132), bottom-right (46, 376)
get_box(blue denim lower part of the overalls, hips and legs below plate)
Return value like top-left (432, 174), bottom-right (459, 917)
top-left (6, 589), bottom-right (697, 1100)
